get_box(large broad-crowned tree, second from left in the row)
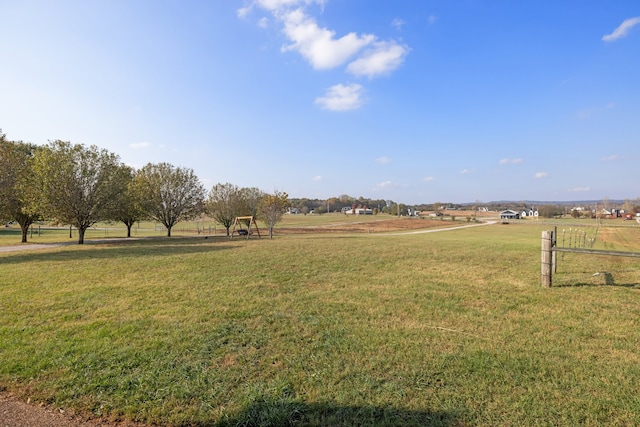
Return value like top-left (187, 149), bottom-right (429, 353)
top-left (33, 141), bottom-right (123, 244)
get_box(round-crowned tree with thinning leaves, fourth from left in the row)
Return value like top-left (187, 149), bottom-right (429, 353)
top-left (134, 163), bottom-right (204, 237)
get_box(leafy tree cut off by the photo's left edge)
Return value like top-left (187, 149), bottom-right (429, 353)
top-left (0, 130), bottom-right (40, 243)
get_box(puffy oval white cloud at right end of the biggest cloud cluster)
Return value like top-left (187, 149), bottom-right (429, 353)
top-left (347, 41), bottom-right (409, 77)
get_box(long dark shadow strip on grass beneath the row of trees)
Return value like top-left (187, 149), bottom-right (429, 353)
top-left (0, 237), bottom-right (233, 265)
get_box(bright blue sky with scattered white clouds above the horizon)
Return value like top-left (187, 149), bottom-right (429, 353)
top-left (0, 0), bottom-right (640, 204)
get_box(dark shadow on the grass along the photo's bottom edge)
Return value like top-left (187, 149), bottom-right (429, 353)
top-left (208, 399), bottom-right (458, 427)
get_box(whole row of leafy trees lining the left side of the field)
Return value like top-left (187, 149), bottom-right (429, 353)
top-left (0, 129), bottom-right (289, 244)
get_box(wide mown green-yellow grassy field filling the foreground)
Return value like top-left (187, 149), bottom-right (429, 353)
top-left (0, 219), bottom-right (640, 426)
